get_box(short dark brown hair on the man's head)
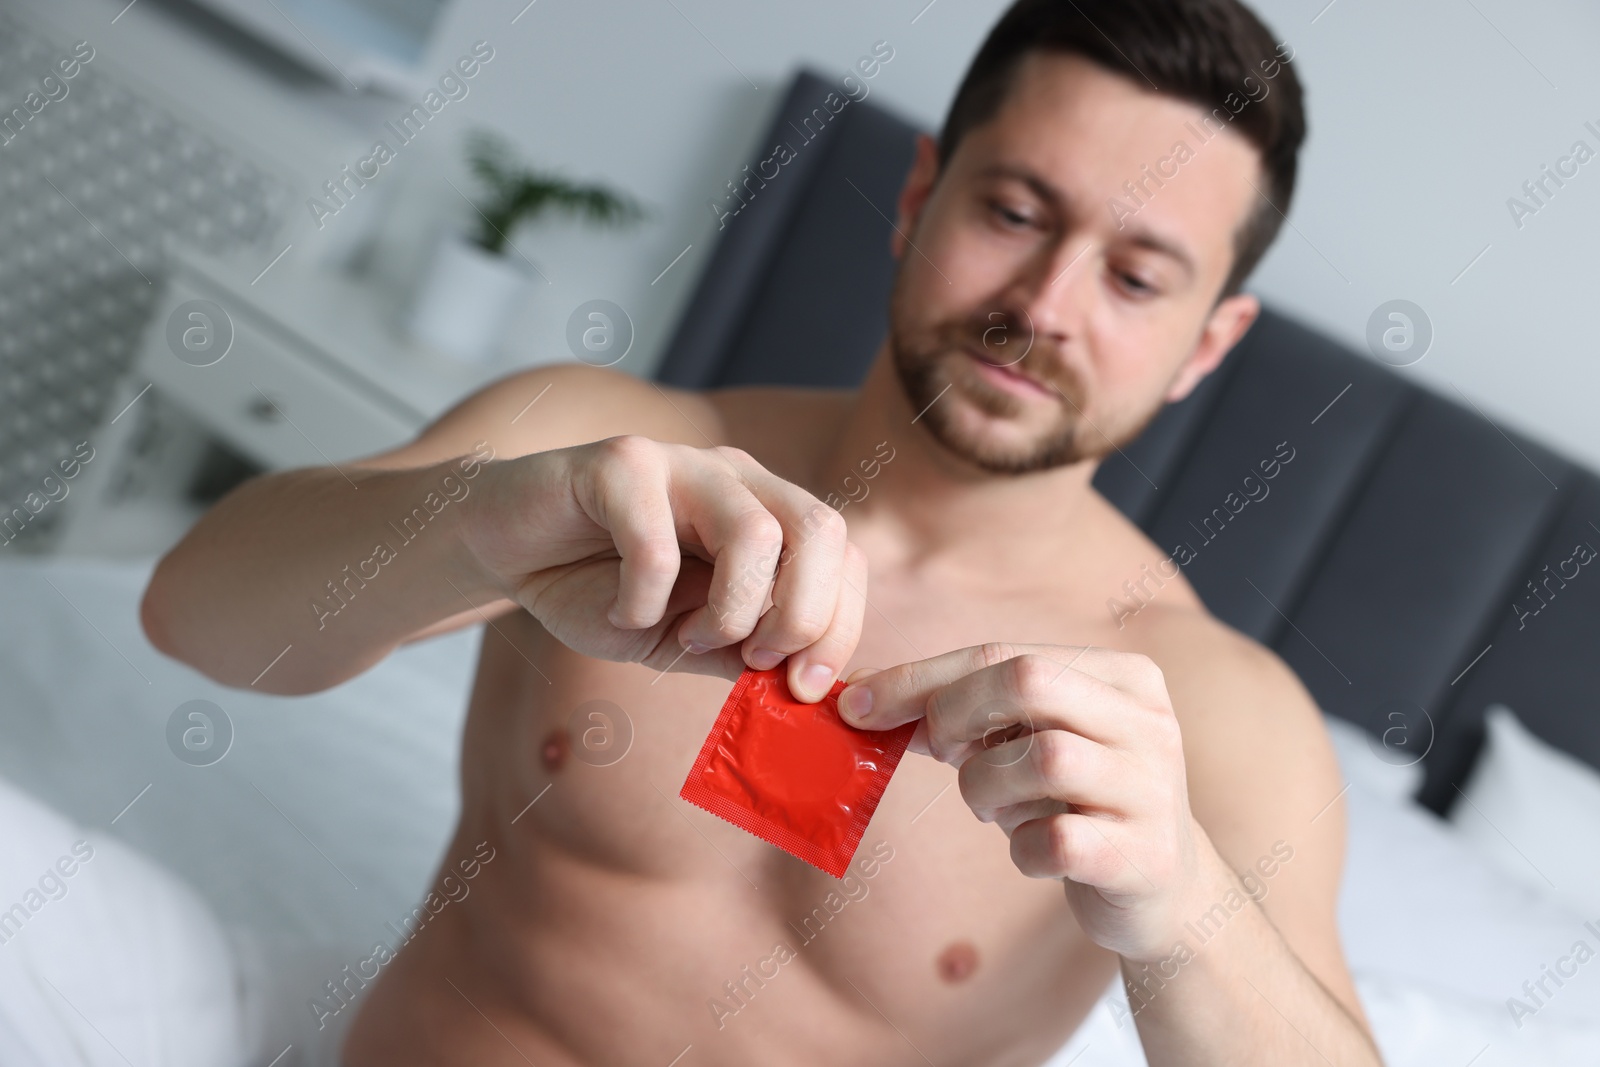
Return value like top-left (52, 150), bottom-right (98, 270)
top-left (939, 0), bottom-right (1306, 296)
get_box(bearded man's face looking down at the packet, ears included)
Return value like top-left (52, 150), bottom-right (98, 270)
top-left (888, 53), bottom-right (1262, 474)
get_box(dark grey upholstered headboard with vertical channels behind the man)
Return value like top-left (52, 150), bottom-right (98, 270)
top-left (659, 72), bottom-right (1600, 811)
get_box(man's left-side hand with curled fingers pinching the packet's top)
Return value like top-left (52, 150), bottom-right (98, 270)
top-left (461, 437), bottom-right (867, 701)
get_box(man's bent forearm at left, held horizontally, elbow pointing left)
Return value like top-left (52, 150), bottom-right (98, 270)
top-left (142, 456), bottom-right (496, 693)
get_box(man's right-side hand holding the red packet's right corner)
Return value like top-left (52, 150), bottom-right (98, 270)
top-left (838, 645), bottom-right (1229, 961)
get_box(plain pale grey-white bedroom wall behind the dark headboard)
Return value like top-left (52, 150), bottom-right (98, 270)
top-left (18, 0), bottom-right (1600, 467)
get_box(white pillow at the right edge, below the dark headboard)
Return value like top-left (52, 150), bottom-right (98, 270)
top-left (1450, 704), bottom-right (1600, 917)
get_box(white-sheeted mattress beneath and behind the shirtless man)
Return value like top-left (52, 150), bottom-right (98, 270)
top-left (0, 558), bottom-right (1600, 1067)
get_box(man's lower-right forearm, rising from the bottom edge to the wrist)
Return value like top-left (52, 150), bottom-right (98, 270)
top-left (1118, 861), bottom-right (1382, 1067)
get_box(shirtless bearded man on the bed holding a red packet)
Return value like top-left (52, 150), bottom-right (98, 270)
top-left (142, 0), bottom-right (1378, 1067)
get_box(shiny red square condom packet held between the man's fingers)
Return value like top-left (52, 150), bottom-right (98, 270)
top-left (678, 664), bottom-right (917, 878)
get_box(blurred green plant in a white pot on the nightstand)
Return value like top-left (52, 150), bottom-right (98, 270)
top-left (408, 131), bottom-right (645, 362)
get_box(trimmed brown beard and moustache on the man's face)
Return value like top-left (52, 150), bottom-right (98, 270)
top-left (888, 285), bottom-right (1160, 475)
